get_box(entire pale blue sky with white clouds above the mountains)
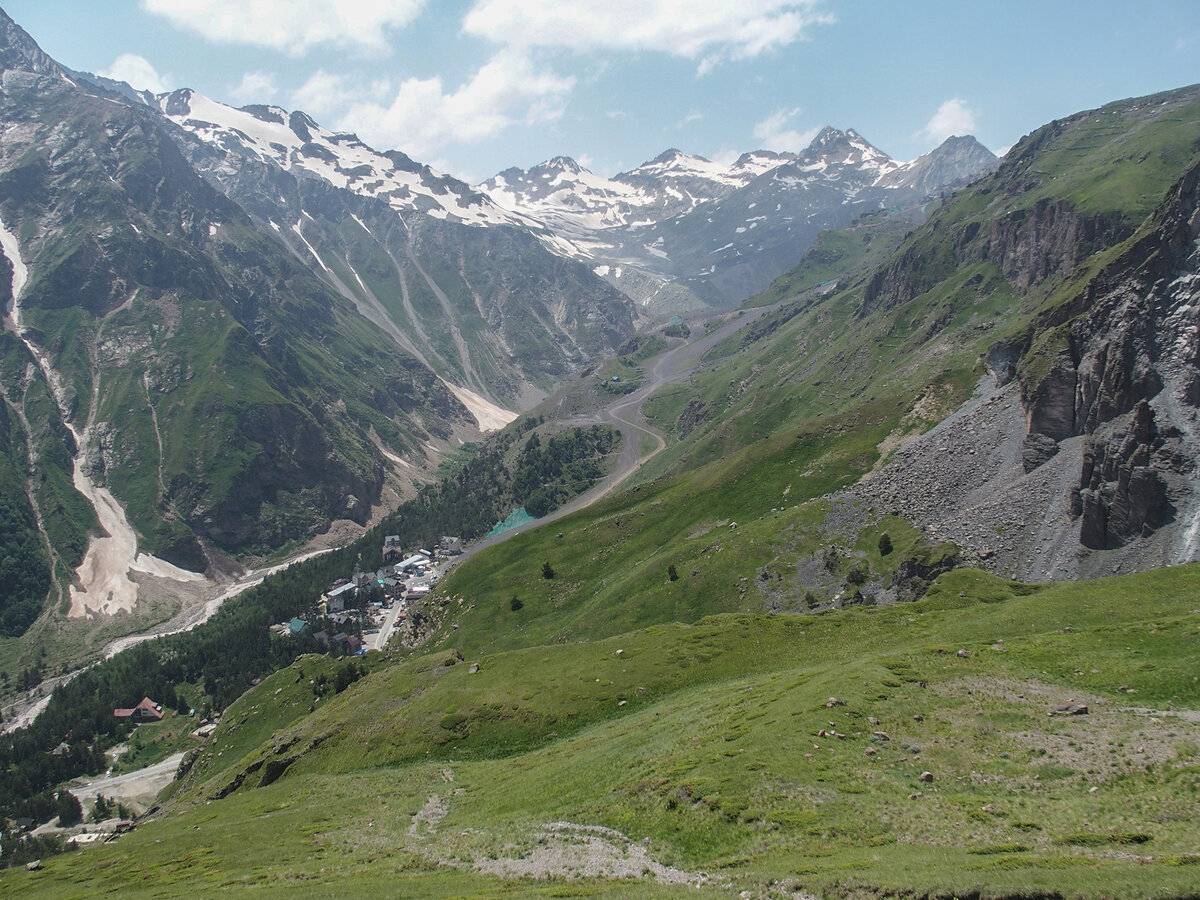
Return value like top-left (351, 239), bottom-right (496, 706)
top-left (2, 0), bottom-right (1200, 181)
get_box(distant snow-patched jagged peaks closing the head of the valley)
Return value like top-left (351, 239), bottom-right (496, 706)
top-left (480, 127), bottom-right (997, 312)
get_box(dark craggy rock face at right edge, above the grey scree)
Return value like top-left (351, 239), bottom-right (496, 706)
top-left (1021, 160), bottom-right (1200, 550)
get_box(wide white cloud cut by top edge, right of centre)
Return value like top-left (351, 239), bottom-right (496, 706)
top-left (462, 0), bottom-right (834, 74)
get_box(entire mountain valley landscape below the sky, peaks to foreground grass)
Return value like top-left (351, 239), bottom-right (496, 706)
top-left (0, 5), bottom-right (1200, 900)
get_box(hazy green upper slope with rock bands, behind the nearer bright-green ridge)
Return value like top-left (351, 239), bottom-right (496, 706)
top-left (646, 86), bottom-right (1200, 489)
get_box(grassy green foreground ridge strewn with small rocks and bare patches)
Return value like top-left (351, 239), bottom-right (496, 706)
top-left (9, 566), bottom-right (1200, 898)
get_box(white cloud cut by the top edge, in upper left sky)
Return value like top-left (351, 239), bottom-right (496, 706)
top-left (142, 0), bottom-right (425, 56)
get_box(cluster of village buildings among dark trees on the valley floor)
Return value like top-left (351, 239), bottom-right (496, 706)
top-left (271, 534), bottom-right (462, 655)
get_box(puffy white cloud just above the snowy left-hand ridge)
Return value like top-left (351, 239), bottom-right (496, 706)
top-left (292, 49), bottom-right (575, 160)
